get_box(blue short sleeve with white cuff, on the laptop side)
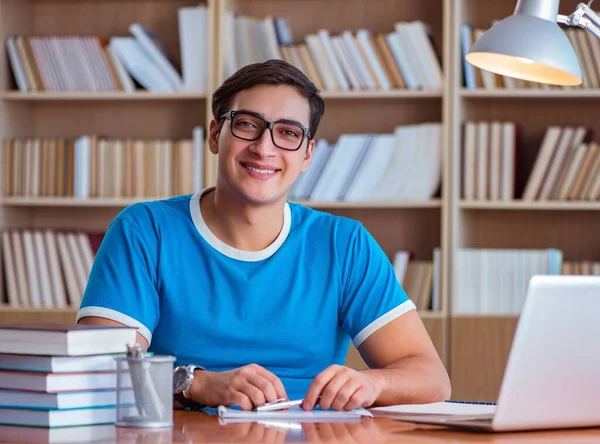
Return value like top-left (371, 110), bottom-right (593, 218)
top-left (340, 224), bottom-right (416, 347)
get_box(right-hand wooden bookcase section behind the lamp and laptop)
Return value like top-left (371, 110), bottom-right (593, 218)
top-left (448, 0), bottom-right (600, 400)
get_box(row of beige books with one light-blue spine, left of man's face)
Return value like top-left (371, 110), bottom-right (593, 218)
top-left (0, 127), bottom-right (204, 198)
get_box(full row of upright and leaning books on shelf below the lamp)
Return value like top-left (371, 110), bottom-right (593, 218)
top-left (462, 121), bottom-right (600, 201)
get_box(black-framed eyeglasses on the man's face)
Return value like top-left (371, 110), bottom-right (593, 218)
top-left (221, 111), bottom-right (311, 151)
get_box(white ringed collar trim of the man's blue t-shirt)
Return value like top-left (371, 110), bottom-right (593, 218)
top-left (190, 187), bottom-right (292, 262)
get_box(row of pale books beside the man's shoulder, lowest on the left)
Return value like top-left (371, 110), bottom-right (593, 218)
top-left (0, 228), bottom-right (103, 309)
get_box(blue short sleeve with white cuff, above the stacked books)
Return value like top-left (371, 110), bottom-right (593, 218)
top-left (77, 217), bottom-right (159, 343)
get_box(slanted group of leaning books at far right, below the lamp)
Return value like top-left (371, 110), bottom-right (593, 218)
top-left (523, 125), bottom-right (600, 201)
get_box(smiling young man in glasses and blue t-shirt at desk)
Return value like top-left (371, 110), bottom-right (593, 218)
top-left (77, 60), bottom-right (450, 410)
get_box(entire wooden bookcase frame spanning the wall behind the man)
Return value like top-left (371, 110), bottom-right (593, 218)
top-left (0, 0), bottom-right (600, 400)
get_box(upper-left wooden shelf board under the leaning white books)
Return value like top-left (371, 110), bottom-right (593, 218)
top-left (0, 90), bottom-right (206, 102)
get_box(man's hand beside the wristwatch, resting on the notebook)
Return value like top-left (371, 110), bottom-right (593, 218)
top-left (190, 364), bottom-right (287, 410)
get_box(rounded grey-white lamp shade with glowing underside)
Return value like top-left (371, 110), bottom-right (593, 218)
top-left (466, 14), bottom-right (581, 86)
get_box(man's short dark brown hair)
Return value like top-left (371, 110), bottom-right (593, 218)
top-left (212, 59), bottom-right (325, 138)
